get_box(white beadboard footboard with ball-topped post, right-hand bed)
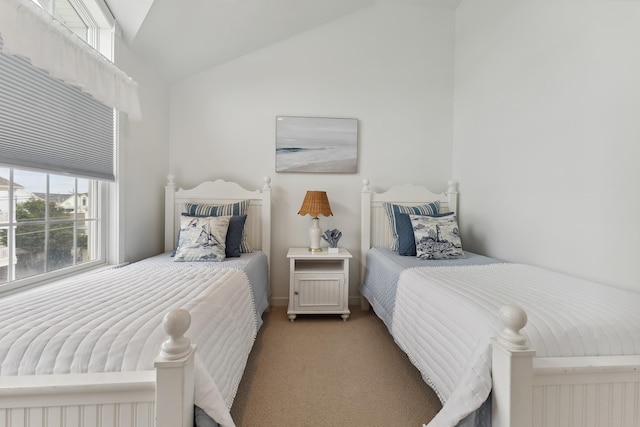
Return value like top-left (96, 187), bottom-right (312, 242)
top-left (492, 305), bottom-right (640, 427)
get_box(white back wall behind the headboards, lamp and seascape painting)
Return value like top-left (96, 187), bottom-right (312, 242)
top-left (170, 0), bottom-right (454, 304)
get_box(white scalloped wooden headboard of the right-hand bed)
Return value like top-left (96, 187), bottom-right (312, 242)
top-left (360, 179), bottom-right (458, 278)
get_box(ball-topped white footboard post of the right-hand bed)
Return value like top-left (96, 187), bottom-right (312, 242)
top-left (491, 305), bottom-right (535, 427)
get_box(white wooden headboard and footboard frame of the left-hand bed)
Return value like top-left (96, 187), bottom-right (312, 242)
top-left (0, 175), bottom-right (271, 427)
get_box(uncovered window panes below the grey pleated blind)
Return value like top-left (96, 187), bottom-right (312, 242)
top-left (0, 167), bottom-right (103, 289)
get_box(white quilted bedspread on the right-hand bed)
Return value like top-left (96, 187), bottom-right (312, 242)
top-left (392, 264), bottom-right (640, 427)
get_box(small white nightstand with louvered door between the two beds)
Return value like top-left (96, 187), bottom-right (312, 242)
top-left (287, 248), bottom-right (351, 322)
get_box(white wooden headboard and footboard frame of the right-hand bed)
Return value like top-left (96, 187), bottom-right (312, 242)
top-left (360, 180), bottom-right (640, 427)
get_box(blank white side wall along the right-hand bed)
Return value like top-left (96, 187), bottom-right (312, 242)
top-left (453, 0), bottom-right (640, 290)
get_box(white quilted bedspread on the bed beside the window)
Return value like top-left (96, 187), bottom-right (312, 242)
top-left (0, 267), bottom-right (257, 426)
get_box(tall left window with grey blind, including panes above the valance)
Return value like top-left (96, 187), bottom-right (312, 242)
top-left (0, 0), bottom-right (116, 292)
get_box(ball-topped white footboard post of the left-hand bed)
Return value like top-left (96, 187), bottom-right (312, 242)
top-left (155, 309), bottom-right (196, 427)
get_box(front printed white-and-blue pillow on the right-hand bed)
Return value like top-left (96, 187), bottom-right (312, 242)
top-left (409, 215), bottom-right (464, 259)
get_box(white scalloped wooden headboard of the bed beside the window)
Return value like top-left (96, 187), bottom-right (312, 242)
top-left (164, 175), bottom-right (271, 262)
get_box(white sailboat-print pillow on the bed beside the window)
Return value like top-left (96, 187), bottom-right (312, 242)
top-left (173, 216), bottom-right (231, 262)
